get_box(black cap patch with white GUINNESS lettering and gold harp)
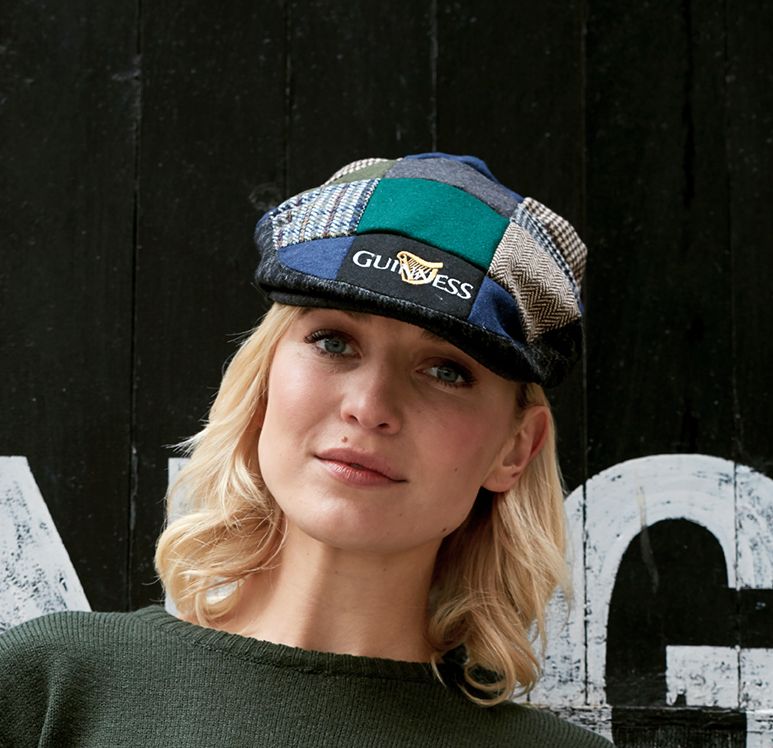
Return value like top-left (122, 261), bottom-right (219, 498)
top-left (338, 234), bottom-right (484, 319)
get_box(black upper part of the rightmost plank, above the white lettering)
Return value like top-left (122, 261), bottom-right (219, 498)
top-left (726, 0), bottom-right (773, 477)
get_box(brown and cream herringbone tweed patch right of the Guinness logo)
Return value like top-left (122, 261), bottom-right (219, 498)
top-left (488, 222), bottom-right (580, 343)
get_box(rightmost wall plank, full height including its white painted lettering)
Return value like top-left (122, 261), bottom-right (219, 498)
top-left (726, 0), bottom-right (773, 704)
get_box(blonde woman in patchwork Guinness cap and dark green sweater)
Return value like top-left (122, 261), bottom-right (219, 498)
top-left (0, 154), bottom-right (608, 747)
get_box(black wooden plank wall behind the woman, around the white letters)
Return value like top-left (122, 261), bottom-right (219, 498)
top-left (0, 0), bottom-right (773, 745)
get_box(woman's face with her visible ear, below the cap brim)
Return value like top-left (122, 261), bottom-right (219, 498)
top-left (258, 309), bottom-right (528, 554)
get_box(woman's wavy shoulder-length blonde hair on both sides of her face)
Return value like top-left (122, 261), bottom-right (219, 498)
top-left (155, 304), bottom-right (568, 705)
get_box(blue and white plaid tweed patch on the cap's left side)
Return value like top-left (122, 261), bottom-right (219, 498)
top-left (273, 179), bottom-right (378, 249)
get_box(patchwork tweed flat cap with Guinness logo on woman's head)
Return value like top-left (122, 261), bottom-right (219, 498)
top-left (255, 153), bottom-right (586, 387)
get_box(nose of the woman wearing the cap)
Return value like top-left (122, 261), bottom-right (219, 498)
top-left (341, 361), bottom-right (403, 434)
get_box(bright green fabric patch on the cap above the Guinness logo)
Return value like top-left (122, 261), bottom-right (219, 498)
top-left (357, 178), bottom-right (508, 270)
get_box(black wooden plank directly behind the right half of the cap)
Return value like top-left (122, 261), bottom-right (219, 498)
top-left (437, 0), bottom-right (593, 489)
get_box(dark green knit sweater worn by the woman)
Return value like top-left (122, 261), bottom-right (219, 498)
top-left (0, 606), bottom-right (609, 748)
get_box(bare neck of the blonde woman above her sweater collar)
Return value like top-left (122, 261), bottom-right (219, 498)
top-left (223, 527), bottom-right (437, 662)
